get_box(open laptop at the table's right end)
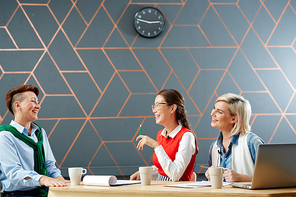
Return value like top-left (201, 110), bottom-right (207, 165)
top-left (232, 143), bottom-right (296, 189)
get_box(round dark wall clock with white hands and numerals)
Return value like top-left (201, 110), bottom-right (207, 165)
top-left (134, 7), bottom-right (165, 38)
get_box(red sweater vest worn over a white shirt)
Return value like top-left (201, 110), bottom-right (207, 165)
top-left (153, 127), bottom-right (197, 181)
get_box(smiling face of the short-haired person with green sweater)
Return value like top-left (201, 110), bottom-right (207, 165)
top-left (15, 91), bottom-right (41, 122)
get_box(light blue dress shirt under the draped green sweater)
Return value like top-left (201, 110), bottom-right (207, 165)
top-left (0, 121), bottom-right (61, 193)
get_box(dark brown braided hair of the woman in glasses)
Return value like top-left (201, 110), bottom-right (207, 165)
top-left (157, 89), bottom-right (191, 130)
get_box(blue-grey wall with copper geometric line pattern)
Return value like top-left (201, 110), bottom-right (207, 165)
top-left (0, 0), bottom-right (296, 178)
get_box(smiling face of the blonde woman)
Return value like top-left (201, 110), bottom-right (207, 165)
top-left (211, 101), bottom-right (237, 132)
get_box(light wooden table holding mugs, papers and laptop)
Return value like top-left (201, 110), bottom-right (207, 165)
top-left (48, 181), bottom-right (296, 197)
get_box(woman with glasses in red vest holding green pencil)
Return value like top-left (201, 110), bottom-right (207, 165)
top-left (130, 89), bottom-right (198, 181)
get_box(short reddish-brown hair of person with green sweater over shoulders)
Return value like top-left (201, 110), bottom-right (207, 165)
top-left (6, 84), bottom-right (39, 115)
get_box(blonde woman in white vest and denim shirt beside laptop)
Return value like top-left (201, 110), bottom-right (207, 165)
top-left (205, 93), bottom-right (264, 182)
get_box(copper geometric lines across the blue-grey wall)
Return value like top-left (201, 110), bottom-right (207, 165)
top-left (0, 0), bottom-right (296, 173)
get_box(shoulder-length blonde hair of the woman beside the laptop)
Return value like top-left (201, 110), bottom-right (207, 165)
top-left (215, 93), bottom-right (252, 136)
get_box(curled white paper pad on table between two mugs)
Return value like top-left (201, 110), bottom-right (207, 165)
top-left (83, 175), bottom-right (141, 186)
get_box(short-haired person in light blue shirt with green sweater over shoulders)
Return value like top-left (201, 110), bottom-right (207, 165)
top-left (0, 85), bottom-right (69, 197)
